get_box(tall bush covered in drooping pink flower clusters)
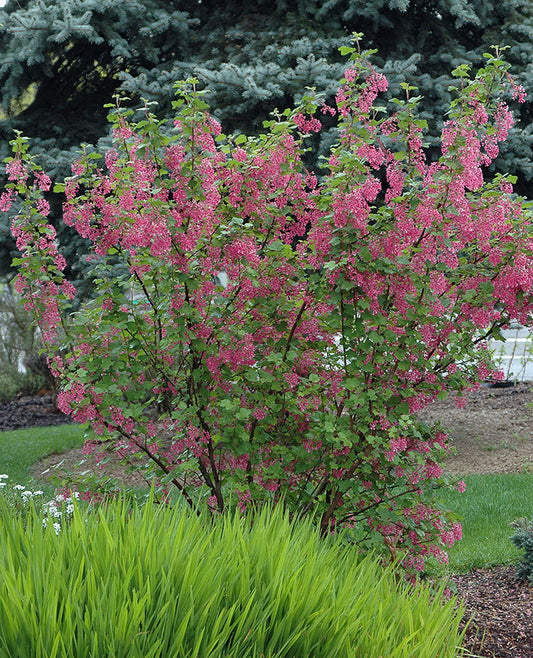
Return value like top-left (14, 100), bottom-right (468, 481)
top-left (4, 38), bottom-right (533, 568)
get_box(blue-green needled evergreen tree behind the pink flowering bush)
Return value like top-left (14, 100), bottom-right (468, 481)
top-left (0, 0), bottom-right (533, 276)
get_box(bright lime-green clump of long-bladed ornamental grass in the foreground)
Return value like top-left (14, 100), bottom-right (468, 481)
top-left (0, 502), bottom-right (462, 658)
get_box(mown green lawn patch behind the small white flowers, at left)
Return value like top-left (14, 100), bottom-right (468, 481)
top-left (0, 424), bottom-right (85, 485)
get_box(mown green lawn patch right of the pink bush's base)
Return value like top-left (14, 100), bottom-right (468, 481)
top-left (442, 473), bottom-right (533, 573)
